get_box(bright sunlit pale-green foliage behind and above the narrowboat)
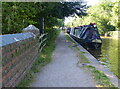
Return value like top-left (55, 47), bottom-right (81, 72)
top-left (67, 0), bottom-right (120, 34)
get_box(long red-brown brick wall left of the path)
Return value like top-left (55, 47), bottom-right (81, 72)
top-left (1, 24), bottom-right (39, 87)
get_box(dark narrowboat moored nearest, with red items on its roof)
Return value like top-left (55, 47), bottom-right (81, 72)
top-left (70, 23), bottom-right (102, 49)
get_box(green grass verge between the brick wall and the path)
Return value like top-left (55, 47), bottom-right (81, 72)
top-left (18, 30), bottom-right (60, 87)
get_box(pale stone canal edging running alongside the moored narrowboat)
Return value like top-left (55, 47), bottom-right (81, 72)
top-left (67, 34), bottom-right (120, 88)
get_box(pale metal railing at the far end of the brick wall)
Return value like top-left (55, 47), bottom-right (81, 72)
top-left (38, 33), bottom-right (48, 52)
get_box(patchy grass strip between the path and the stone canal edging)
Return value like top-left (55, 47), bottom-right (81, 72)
top-left (66, 32), bottom-right (118, 89)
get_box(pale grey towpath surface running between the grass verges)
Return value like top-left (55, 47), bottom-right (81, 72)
top-left (30, 32), bottom-right (96, 87)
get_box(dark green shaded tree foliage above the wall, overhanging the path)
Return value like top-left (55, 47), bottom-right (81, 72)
top-left (2, 2), bottom-right (86, 34)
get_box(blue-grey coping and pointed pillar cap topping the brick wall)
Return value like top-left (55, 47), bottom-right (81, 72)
top-left (0, 25), bottom-right (39, 47)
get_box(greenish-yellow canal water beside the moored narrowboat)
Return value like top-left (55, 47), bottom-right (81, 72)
top-left (87, 38), bottom-right (120, 78)
